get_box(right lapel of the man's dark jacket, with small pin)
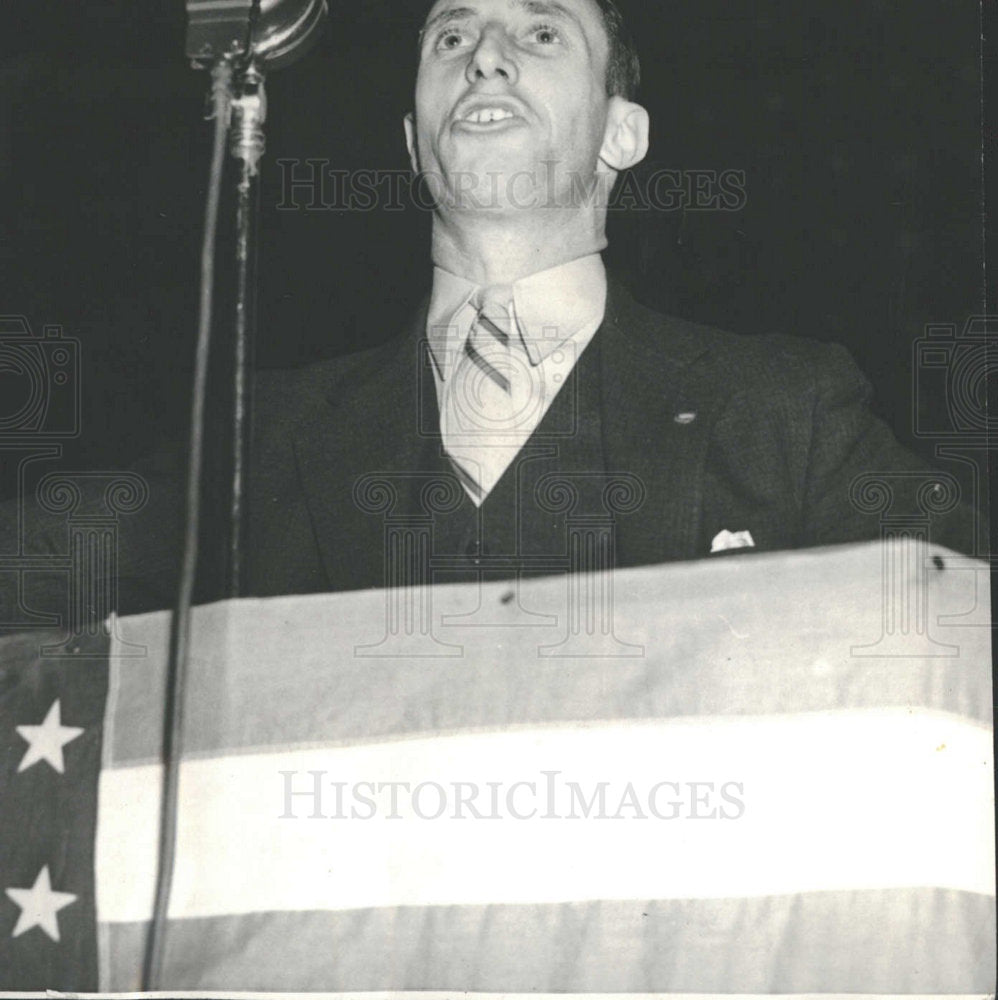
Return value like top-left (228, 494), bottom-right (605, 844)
top-left (600, 282), bottom-right (719, 566)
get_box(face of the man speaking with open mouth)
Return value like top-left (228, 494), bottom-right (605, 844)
top-left (407, 0), bottom-right (609, 208)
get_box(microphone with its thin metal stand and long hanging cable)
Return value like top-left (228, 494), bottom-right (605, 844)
top-left (141, 0), bottom-right (328, 992)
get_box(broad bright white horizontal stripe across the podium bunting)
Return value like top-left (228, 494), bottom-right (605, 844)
top-left (96, 710), bottom-right (994, 923)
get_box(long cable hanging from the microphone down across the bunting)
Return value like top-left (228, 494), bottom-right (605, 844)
top-left (142, 59), bottom-right (233, 992)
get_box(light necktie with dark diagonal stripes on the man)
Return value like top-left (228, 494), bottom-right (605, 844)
top-left (441, 286), bottom-right (542, 505)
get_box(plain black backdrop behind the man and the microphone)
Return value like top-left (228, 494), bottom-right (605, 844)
top-left (0, 0), bottom-right (983, 488)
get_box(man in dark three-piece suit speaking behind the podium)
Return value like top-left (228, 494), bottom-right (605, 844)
top-left (0, 0), bottom-right (973, 612)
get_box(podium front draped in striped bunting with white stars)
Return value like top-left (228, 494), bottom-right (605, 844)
top-left (0, 541), bottom-right (995, 994)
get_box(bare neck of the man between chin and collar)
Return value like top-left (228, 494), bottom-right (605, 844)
top-left (433, 213), bottom-right (607, 286)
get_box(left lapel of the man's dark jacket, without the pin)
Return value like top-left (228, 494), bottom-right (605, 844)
top-left (295, 304), bottom-right (432, 590)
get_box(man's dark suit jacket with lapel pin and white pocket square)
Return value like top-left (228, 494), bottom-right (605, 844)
top-left (4, 283), bottom-right (973, 612)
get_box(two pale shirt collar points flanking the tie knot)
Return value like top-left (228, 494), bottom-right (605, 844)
top-left (426, 253), bottom-right (606, 381)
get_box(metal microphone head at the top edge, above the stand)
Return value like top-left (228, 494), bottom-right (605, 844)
top-left (186, 0), bottom-right (329, 70)
